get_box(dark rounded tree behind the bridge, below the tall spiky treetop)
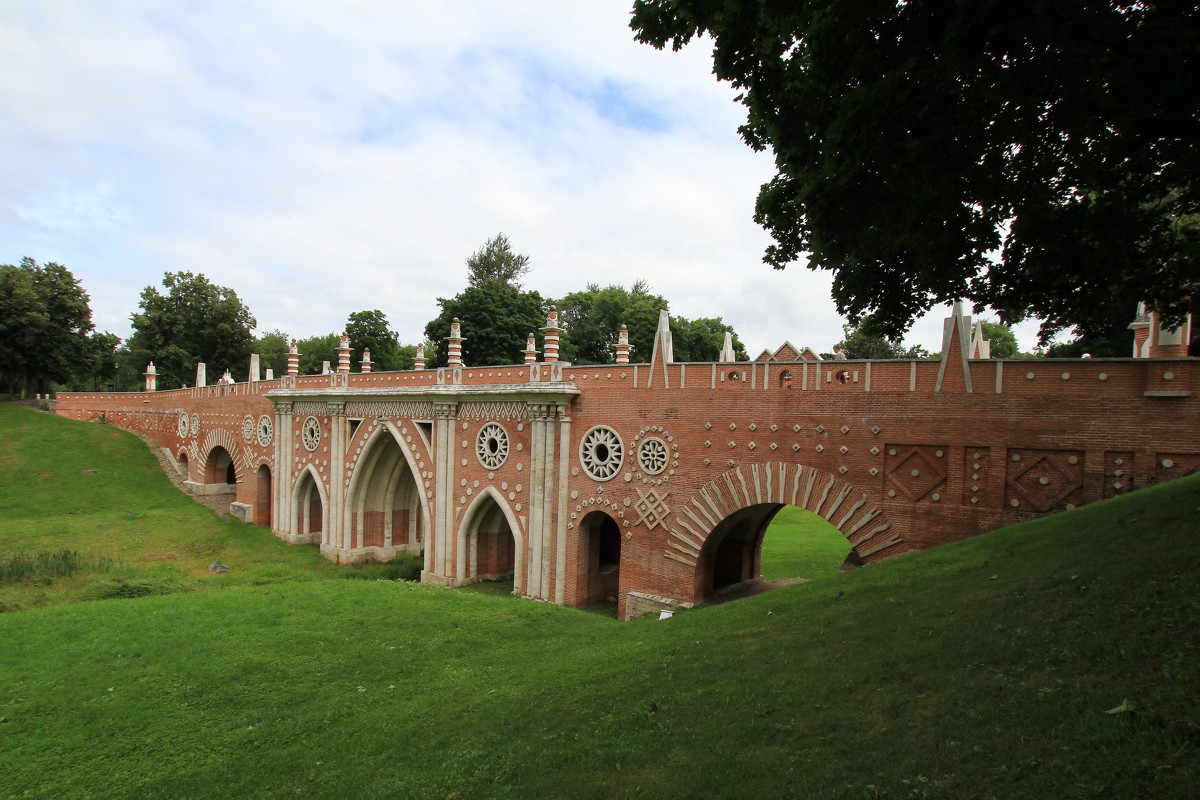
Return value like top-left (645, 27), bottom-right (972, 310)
top-left (425, 281), bottom-right (546, 367)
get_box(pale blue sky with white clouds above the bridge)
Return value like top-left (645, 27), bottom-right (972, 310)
top-left (0, 0), bottom-right (1036, 355)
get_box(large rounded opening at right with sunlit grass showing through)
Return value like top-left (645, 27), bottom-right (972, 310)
top-left (696, 503), bottom-right (860, 602)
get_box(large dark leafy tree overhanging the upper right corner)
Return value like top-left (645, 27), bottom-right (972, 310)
top-left (631, 0), bottom-right (1200, 337)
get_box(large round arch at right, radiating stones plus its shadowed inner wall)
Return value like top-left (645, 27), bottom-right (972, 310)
top-left (665, 462), bottom-right (908, 601)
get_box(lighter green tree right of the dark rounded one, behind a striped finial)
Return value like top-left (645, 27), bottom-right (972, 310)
top-left (554, 281), bottom-right (667, 363)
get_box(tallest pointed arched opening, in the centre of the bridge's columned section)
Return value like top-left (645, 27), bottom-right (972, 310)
top-left (350, 431), bottom-right (422, 558)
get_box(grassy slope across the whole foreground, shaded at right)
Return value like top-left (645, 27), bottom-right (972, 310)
top-left (0, 410), bottom-right (1200, 798)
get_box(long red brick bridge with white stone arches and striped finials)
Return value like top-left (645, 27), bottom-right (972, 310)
top-left (56, 307), bottom-right (1200, 619)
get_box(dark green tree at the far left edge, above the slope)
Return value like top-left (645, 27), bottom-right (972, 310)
top-left (0, 258), bottom-right (92, 397)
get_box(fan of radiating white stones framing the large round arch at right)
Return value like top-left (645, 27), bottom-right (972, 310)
top-left (664, 462), bottom-right (910, 597)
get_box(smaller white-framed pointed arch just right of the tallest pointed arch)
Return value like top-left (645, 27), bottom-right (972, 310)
top-left (455, 486), bottom-right (527, 594)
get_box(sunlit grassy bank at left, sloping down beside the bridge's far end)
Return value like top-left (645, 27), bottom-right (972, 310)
top-left (0, 403), bottom-right (337, 610)
